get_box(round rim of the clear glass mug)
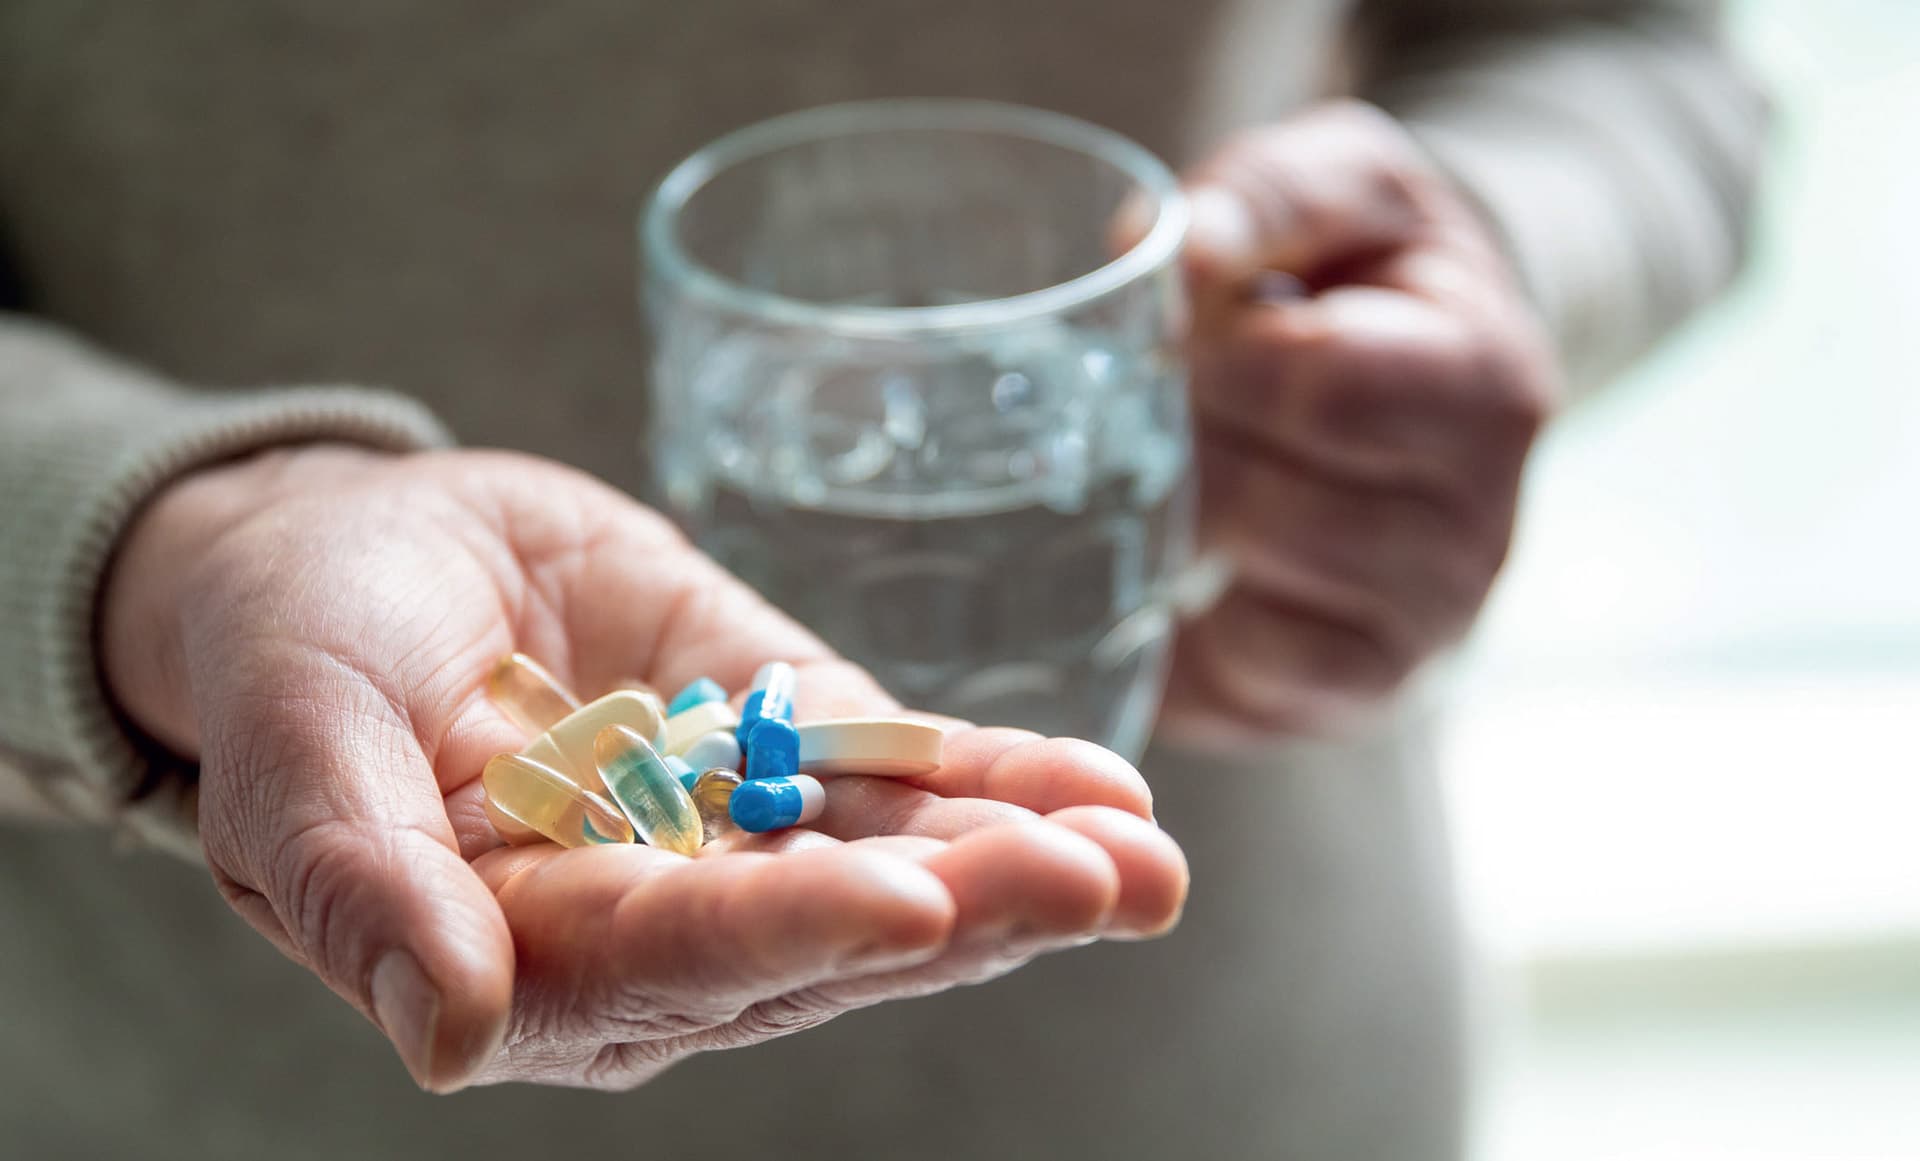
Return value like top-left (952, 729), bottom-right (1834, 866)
top-left (639, 98), bottom-right (1187, 336)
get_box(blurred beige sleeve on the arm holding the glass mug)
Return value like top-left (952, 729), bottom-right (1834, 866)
top-left (1354, 0), bottom-right (1766, 386)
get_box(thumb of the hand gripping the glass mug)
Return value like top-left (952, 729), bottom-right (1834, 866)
top-left (1185, 102), bottom-right (1427, 296)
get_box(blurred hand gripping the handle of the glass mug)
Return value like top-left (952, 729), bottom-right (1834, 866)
top-left (1119, 102), bottom-right (1561, 746)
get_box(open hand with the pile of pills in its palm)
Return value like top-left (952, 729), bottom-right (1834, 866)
top-left (100, 447), bottom-right (1187, 1090)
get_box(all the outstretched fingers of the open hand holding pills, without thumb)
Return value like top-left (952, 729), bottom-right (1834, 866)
top-left (478, 806), bottom-right (1187, 1088)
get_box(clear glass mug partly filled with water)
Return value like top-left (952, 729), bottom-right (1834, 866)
top-left (641, 102), bottom-right (1192, 756)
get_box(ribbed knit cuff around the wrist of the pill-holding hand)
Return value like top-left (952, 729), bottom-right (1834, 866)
top-left (40, 388), bottom-right (449, 858)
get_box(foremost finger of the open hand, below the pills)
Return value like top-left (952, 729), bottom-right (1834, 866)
top-left (476, 832), bottom-right (956, 1040)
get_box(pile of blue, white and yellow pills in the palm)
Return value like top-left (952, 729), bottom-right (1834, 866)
top-left (480, 652), bottom-right (941, 854)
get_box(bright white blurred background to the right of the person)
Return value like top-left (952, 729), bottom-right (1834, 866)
top-left (1446, 0), bottom-right (1920, 1161)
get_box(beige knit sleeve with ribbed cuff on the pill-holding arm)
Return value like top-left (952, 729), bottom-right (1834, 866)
top-left (0, 315), bottom-right (447, 854)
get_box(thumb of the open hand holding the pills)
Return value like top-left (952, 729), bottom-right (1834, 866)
top-left (194, 647), bottom-right (513, 1092)
